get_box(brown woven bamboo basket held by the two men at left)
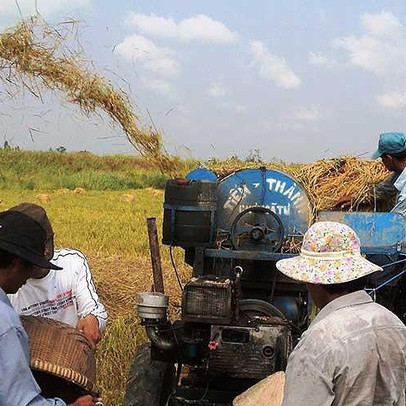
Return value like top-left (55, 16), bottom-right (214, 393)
top-left (21, 316), bottom-right (98, 403)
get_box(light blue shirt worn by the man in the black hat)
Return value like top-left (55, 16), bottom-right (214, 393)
top-left (0, 288), bottom-right (66, 406)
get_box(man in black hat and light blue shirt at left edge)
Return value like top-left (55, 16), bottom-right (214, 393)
top-left (0, 211), bottom-right (101, 406)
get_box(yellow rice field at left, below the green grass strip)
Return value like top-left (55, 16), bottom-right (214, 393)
top-left (0, 188), bottom-right (189, 406)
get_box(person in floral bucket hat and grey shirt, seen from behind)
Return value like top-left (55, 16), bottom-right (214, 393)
top-left (276, 222), bottom-right (406, 406)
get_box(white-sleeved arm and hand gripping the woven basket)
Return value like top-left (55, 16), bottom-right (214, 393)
top-left (75, 254), bottom-right (107, 346)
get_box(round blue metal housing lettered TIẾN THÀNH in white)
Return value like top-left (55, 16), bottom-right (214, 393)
top-left (217, 168), bottom-right (312, 237)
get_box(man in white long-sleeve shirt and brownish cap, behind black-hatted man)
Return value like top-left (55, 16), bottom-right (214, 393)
top-left (9, 203), bottom-right (107, 348)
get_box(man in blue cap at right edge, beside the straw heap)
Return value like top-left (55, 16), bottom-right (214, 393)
top-left (336, 132), bottom-right (406, 216)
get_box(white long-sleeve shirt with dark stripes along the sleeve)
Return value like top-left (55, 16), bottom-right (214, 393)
top-left (9, 249), bottom-right (107, 331)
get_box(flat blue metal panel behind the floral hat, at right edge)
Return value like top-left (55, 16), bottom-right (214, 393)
top-left (318, 211), bottom-right (406, 255)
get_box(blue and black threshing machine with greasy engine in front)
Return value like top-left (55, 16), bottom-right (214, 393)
top-left (125, 168), bottom-right (406, 406)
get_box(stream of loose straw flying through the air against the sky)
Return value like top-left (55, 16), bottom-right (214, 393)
top-left (0, 18), bottom-right (179, 173)
